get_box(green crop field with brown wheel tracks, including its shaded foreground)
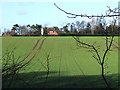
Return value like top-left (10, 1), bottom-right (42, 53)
top-left (2, 36), bottom-right (119, 88)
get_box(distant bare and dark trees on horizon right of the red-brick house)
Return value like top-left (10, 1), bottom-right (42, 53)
top-left (63, 18), bottom-right (120, 35)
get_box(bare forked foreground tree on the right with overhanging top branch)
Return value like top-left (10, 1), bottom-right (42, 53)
top-left (54, 3), bottom-right (120, 88)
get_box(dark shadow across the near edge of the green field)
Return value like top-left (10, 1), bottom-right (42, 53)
top-left (3, 72), bottom-right (118, 88)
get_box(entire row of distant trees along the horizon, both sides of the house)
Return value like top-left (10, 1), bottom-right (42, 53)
top-left (3, 18), bottom-right (120, 35)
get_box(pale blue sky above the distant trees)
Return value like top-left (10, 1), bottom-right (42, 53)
top-left (0, 0), bottom-right (119, 34)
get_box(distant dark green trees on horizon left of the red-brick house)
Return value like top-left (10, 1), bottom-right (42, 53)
top-left (2, 24), bottom-right (59, 35)
